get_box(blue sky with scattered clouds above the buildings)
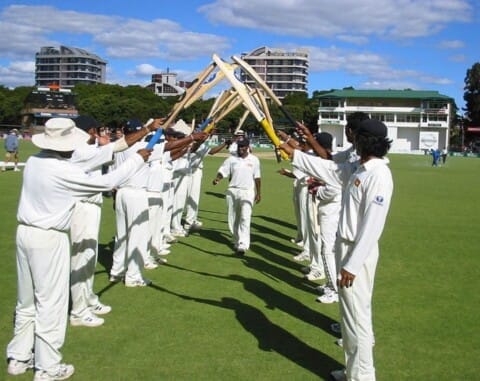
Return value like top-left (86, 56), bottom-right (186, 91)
top-left (0, 0), bottom-right (480, 108)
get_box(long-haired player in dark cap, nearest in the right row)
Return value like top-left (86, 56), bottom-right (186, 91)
top-left (281, 119), bottom-right (393, 381)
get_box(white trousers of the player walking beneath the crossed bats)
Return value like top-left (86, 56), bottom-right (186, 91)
top-left (226, 188), bottom-right (255, 250)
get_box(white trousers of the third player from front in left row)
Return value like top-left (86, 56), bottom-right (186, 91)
top-left (110, 187), bottom-right (150, 282)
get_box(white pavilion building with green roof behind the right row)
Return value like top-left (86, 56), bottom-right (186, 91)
top-left (318, 90), bottom-right (455, 153)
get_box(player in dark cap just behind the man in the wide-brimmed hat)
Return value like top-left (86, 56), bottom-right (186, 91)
top-left (70, 115), bottom-right (162, 327)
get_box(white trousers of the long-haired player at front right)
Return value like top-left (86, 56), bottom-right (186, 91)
top-left (336, 239), bottom-right (378, 381)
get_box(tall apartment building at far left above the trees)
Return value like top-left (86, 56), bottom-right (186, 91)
top-left (35, 46), bottom-right (107, 88)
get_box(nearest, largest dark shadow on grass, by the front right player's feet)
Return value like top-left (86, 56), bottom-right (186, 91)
top-left (151, 279), bottom-right (342, 379)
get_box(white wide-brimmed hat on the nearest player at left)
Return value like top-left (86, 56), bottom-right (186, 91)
top-left (32, 118), bottom-right (90, 152)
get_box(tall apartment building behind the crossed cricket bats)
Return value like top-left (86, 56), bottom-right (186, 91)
top-left (240, 47), bottom-right (309, 99)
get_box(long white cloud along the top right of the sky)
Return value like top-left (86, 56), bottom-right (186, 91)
top-left (199, 0), bottom-right (473, 38)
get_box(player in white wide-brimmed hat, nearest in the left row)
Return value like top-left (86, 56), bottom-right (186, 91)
top-left (7, 118), bottom-right (150, 381)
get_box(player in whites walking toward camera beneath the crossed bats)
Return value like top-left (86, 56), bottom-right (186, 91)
top-left (213, 138), bottom-right (261, 256)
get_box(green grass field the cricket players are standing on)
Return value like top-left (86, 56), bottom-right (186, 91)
top-left (0, 142), bottom-right (480, 381)
